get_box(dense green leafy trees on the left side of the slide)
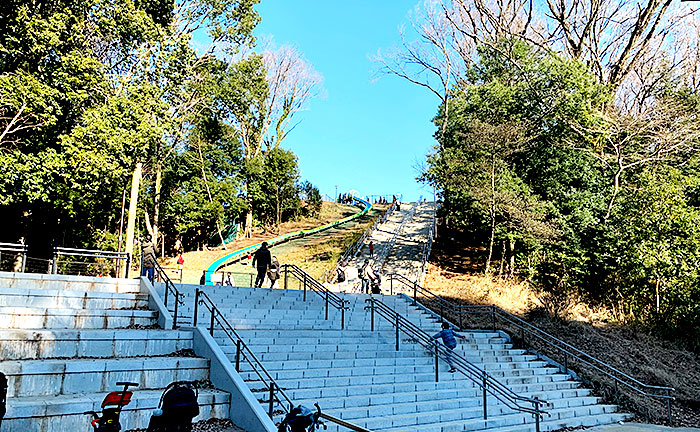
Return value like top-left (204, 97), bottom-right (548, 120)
top-left (0, 0), bottom-right (322, 255)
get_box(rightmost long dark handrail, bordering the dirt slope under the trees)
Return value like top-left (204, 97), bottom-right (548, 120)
top-left (387, 274), bottom-right (675, 425)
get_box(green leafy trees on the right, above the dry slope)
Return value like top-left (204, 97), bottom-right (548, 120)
top-left (422, 40), bottom-right (700, 349)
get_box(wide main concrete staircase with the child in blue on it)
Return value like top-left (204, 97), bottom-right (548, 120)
top-left (171, 286), bottom-right (627, 432)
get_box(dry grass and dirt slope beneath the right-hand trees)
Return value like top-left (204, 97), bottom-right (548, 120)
top-left (425, 235), bottom-right (700, 427)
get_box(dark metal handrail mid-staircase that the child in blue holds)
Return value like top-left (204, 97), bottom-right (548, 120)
top-left (365, 296), bottom-right (547, 432)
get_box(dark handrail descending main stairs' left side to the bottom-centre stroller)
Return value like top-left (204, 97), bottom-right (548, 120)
top-left (192, 288), bottom-right (371, 432)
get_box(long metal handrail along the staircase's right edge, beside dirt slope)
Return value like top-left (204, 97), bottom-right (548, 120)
top-left (388, 273), bottom-right (676, 424)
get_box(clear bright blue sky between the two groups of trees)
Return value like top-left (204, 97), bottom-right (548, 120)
top-left (256, 0), bottom-right (438, 201)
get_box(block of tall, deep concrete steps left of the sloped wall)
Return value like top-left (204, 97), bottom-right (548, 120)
top-left (0, 272), bottom-right (229, 432)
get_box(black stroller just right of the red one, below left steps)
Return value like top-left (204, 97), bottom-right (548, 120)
top-left (147, 381), bottom-right (199, 432)
